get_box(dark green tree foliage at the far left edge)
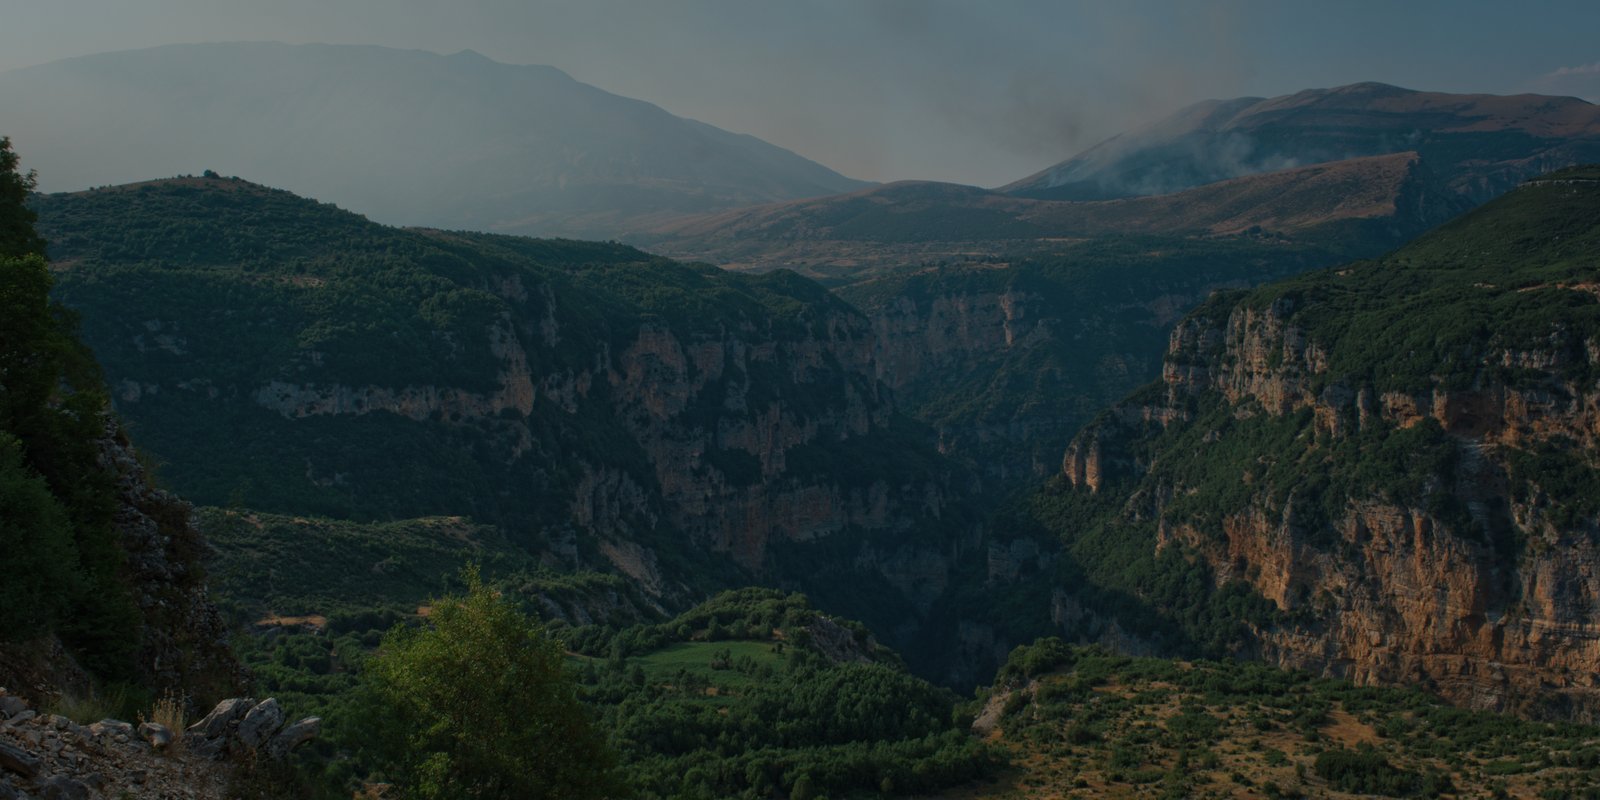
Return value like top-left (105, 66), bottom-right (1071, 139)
top-left (0, 139), bottom-right (138, 678)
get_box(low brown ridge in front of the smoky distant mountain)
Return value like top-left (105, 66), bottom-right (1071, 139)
top-left (630, 152), bottom-right (1470, 278)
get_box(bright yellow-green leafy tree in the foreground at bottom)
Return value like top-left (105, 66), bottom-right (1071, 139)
top-left (363, 568), bottom-right (621, 800)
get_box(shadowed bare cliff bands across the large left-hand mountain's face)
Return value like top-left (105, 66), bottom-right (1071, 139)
top-left (106, 259), bottom-right (952, 608)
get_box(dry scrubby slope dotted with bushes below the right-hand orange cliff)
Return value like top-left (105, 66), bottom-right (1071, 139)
top-left (981, 638), bottom-right (1600, 797)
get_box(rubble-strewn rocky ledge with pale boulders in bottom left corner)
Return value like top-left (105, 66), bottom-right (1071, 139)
top-left (0, 690), bottom-right (322, 800)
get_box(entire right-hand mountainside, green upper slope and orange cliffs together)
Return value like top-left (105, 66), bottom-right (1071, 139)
top-left (1059, 172), bottom-right (1600, 720)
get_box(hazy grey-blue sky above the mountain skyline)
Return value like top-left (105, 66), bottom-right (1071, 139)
top-left (0, 0), bottom-right (1600, 186)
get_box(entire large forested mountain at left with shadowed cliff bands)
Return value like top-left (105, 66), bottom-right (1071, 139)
top-left (38, 179), bottom-right (971, 640)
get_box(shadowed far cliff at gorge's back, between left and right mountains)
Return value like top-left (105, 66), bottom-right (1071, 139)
top-left (838, 237), bottom-right (1341, 485)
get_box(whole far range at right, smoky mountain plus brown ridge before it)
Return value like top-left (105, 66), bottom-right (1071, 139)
top-left (629, 83), bottom-right (1600, 283)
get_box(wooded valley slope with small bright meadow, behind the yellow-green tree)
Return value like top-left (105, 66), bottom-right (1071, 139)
top-left (203, 509), bottom-right (1000, 798)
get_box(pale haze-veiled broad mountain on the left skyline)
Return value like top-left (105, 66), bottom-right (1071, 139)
top-left (0, 43), bottom-right (866, 238)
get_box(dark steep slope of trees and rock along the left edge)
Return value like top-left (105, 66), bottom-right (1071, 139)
top-left (0, 138), bottom-right (237, 712)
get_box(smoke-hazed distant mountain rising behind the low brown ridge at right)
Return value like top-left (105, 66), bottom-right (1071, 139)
top-left (1000, 83), bottom-right (1600, 203)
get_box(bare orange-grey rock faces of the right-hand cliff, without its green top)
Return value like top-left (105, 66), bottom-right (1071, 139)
top-left (1062, 289), bottom-right (1600, 720)
